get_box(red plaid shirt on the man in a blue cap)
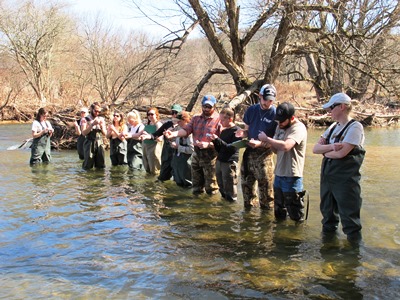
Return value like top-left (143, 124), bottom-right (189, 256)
top-left (183, 111), bottom-right (221, 142)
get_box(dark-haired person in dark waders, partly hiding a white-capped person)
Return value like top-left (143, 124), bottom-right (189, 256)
top-left (81, 102), bottom-right (107, 170)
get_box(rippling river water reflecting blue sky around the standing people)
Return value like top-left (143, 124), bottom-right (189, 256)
top-left (0, 125), bottom-right (400, 299)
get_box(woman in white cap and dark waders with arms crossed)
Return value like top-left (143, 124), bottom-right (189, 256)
top-left (313, 93), bottom-right (365, 242)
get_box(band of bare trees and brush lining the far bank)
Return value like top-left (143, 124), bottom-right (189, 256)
top-left (0, 0), bottom-right (400, 109)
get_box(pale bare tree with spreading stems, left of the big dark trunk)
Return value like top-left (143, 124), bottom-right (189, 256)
top-left (82, 18), bottom-right (174, 104)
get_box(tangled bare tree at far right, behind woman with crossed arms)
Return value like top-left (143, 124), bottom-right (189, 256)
top-left (293, 0), bottom-right (400, 99)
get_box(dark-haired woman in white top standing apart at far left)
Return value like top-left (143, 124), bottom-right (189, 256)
top-left (29, 108), bottom-right (54, 165)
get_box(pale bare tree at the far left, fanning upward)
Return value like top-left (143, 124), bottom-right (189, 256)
top-left (0, 1), bottom-right (68, 101)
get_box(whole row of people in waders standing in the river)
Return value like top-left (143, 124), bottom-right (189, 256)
top-left (30, 84), bottom-right (365, 241)
